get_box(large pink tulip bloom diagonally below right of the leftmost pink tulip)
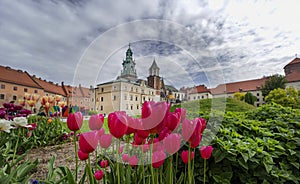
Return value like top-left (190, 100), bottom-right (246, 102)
top-left (79, 132), bottom-right (98, 153)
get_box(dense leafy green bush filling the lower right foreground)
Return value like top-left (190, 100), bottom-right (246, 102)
top-left (191, 104), bottom-right (300, 183)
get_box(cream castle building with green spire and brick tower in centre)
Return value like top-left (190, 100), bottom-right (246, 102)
top-left (95, 45), bottom-right (161, 116)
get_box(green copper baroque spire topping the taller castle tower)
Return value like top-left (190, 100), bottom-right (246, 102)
top-left (118, 44), bottom-right (137, 81)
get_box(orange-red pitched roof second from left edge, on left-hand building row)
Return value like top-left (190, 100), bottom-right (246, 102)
top-left (31, 75), bottom-right (66, 96)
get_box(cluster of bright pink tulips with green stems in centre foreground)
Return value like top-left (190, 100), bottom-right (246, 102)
top-left (60, 101), bottom-right (212, 184)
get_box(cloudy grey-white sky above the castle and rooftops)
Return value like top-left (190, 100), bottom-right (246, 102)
top-left (0, 0), bottom-right (300, 88)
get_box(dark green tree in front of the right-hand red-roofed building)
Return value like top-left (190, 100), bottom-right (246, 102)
top-left (261, 74), bottom-right (287, 96)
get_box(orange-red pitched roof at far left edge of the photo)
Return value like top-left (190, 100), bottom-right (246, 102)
top-left (0, 66), bottom-right (42, 89)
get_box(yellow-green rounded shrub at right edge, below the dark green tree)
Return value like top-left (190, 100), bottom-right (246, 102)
top-left (265, 87), bottom-right (300, 109)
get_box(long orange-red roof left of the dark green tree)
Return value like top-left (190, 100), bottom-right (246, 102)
top-left (210, 77), bottom-right (268, 95)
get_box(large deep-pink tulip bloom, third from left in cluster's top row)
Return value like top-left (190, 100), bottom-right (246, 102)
top-left (108, 112), bottom-right (128, 138)
